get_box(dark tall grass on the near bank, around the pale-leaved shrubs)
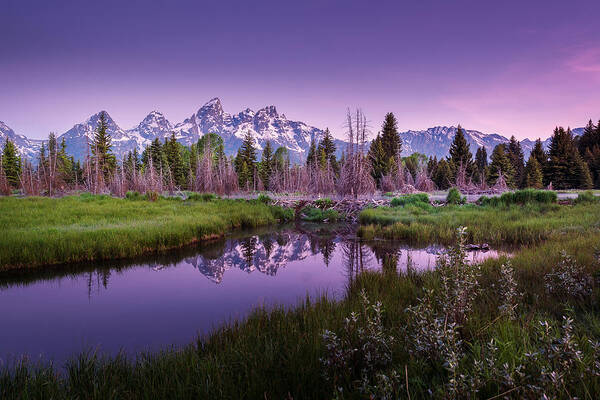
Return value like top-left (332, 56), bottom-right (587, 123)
top-left (0, 227), bottom-right (600, 399)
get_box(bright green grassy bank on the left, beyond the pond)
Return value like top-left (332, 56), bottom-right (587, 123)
top-left (0, 195), bottom-right (292, 270)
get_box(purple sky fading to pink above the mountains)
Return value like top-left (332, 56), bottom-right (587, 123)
top-left (0, 0), bottom-right (600, 138)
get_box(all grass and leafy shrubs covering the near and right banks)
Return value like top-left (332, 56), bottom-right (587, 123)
top-left (0, 195), bottom-right (600, 399)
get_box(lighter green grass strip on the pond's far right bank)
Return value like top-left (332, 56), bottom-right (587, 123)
top-left (359, 203), bottom-right (600, 245)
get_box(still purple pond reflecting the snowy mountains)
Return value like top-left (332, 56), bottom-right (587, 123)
top-left (0, 225), bottom-right (506, 366)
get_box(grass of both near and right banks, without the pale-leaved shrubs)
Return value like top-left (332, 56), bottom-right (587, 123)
top-left (0, 203), bottom-right (600, 399)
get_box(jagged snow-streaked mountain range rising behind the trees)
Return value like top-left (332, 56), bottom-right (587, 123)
top-left (0, 98), bottom-right (583, 162)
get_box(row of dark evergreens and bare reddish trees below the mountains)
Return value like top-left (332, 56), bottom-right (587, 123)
top-left (0, 110), bottom-right (600, 196)
